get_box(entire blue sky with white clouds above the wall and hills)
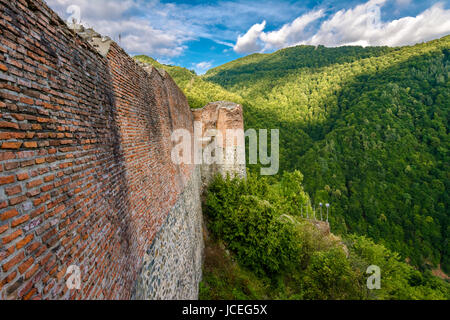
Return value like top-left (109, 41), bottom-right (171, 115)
top-left (47, 0), bottom-right (450, 74)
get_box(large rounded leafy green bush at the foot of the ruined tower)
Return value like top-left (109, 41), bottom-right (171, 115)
top-left (206, 172), bottom-right (301, 275)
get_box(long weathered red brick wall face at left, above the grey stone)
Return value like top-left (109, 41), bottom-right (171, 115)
top-left (0, 0), bottom-right (201, 299)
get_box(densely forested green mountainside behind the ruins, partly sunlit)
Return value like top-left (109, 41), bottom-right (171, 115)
top-left (135, 36), bottom-right (450, 297)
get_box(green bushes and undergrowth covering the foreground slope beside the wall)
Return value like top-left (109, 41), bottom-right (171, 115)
top-left (204, 171), bottom-right (450, 300)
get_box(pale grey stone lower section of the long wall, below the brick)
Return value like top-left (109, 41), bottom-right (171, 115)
top-left (134, 167), bottom-right (204, 300)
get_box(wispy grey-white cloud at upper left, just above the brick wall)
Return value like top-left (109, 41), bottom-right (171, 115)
top-left (47, 0), bottom-right (195, 58)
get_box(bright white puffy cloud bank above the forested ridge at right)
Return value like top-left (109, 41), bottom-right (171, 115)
top-left (234, 0), bottom-right (450, 53)
